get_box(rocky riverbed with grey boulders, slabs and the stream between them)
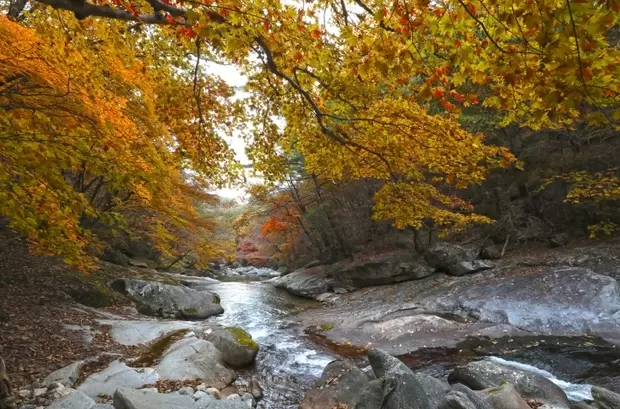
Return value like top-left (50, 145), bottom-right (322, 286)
top-left (4, 239), bottom-right (620, 409)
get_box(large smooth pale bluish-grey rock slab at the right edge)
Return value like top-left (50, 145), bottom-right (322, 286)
top-left (421, 268), bottom-right (620, 342)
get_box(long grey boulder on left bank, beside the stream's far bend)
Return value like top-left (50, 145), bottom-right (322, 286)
top-left (112, 278), bottom-right (224, 319)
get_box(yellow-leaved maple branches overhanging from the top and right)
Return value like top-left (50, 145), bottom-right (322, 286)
top-left (2, 0), bottom-right (620, 264)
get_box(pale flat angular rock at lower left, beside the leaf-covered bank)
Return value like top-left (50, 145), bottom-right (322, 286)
top-left (77, 361), bottom-right (159, 398)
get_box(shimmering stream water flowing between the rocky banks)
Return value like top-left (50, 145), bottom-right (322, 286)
top-left (194, 280), bottom-right (335, 409)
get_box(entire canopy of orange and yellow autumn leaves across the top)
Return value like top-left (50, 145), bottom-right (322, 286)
top-left (0, 0), bottom-right (620, 266)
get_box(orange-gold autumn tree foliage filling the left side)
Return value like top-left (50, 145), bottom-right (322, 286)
top-left (0, 9), bottom-right (236, 268)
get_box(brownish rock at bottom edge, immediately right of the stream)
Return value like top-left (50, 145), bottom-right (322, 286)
top-left (299, 360), bottom-right (371, 409)
